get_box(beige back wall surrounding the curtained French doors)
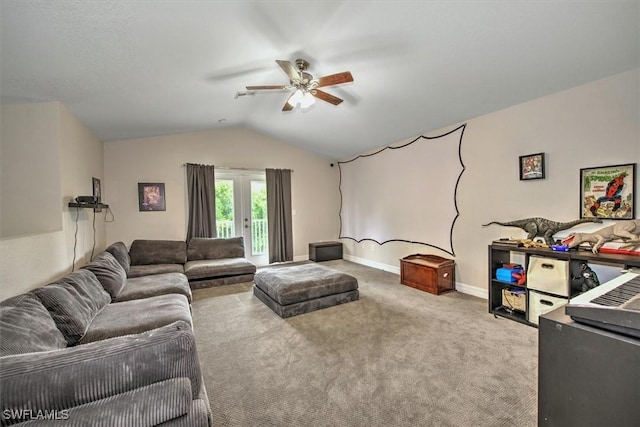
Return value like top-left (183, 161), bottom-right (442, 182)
top-left (103, 128), bottom-right (340, 258)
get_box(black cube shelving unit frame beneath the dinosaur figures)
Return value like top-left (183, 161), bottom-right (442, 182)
top-left (488, 243), bottom-right (640, 327)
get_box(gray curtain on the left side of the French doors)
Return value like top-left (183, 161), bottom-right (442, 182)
top-left (187, 163), bottom-right (216, 242)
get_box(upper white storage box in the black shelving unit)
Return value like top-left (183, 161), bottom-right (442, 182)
top-left (527, 256), bottom-right (571, 297)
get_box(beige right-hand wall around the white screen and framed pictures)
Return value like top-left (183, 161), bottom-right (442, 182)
top-left (344, 69), bottom-right (640, 296)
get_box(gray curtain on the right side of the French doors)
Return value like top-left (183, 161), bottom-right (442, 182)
top-left (266, 169), bottom-right (293, 263)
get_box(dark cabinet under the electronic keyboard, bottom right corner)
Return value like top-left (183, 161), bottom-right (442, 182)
top-left (538, 307), bottom-right (640, 427)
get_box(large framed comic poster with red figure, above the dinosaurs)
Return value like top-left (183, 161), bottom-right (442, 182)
top-left (580, 163), bottom-right (636, 219)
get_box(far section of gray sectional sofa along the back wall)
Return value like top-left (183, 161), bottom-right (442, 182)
top-left (107, 237), bottom-right (256, 289)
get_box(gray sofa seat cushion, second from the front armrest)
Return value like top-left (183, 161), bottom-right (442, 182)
top-left (116, 273), bottom-right (191, 302)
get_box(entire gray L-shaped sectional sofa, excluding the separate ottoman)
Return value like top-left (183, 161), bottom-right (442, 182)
top-left (0, 239), bottom-right (255, 426)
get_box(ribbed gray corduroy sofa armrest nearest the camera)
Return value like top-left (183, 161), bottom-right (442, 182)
top-left (0, 322), bottom-right (202, 425)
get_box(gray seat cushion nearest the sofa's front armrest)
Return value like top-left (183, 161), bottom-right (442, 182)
top-left (80, 294), bottom-right (191, 344)
